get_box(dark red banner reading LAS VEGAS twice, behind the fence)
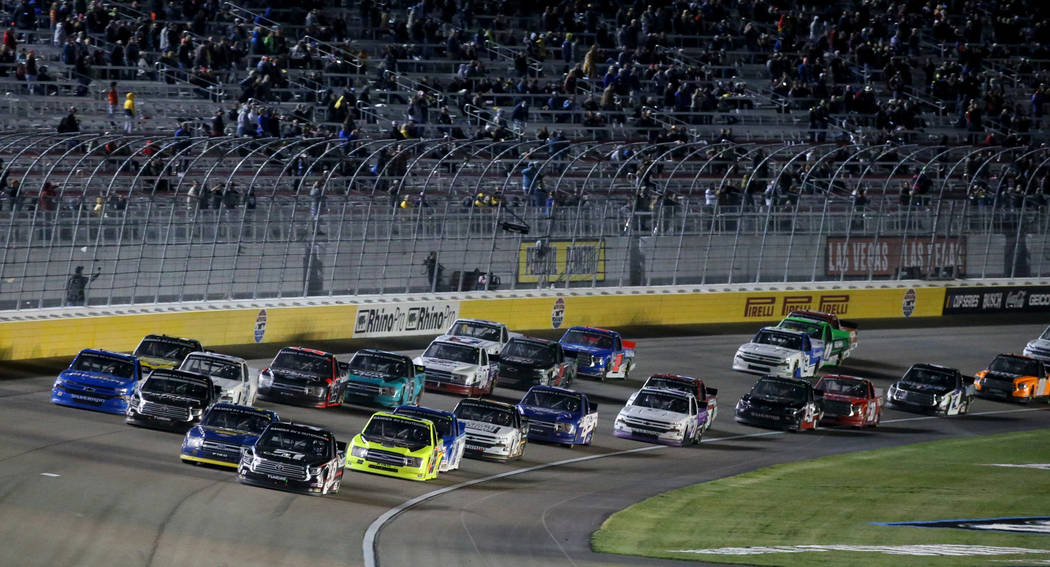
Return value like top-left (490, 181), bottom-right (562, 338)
top-left (824, 236), bottom-right (966, 277)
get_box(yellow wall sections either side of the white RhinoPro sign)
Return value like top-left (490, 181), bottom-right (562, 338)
top-left (0, 288), bottom-right (945, 360)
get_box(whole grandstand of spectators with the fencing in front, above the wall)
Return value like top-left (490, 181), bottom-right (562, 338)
top-left (0, 0), bottom-right (1050, 307)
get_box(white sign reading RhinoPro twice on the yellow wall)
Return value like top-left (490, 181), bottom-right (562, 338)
top-left (354, 301), bottom-right (459, 338)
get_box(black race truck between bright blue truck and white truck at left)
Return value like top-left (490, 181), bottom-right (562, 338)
top-left (125, 369), bottom-right (218, 429)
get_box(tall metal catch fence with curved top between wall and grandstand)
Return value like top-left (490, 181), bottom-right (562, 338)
top-left (0, 132), bottom-right (1050, 310)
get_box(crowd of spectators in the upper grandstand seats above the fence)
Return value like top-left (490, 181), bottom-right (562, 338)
top-left (0, 0), bottom-right (1050, 214)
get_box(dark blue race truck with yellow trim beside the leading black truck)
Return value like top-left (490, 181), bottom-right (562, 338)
top-left (179, 402), bottom-right (279, 468)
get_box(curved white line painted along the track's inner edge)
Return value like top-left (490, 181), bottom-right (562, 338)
top-left (361, 407), bottom-right (1045, 567)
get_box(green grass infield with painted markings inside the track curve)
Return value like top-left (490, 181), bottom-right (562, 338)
top-left (591, 429), bottom-right (1050, 567)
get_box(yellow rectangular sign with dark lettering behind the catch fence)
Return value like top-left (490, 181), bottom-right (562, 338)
top-left (518, 240), bottom-right (605, 284)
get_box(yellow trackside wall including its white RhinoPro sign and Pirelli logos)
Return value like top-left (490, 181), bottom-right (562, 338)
top-left (0, 281), bottom-right (965, 360)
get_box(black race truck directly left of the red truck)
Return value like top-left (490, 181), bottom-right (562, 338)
top-left (735, 376), bottom-right (824, 432)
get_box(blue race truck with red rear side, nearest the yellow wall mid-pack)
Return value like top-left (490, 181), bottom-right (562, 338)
top-left (558, 327), bottom-right (635, 380)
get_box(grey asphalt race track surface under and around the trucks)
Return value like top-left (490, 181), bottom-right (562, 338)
top-left (0, 324), bottom-right (1050, 567)
